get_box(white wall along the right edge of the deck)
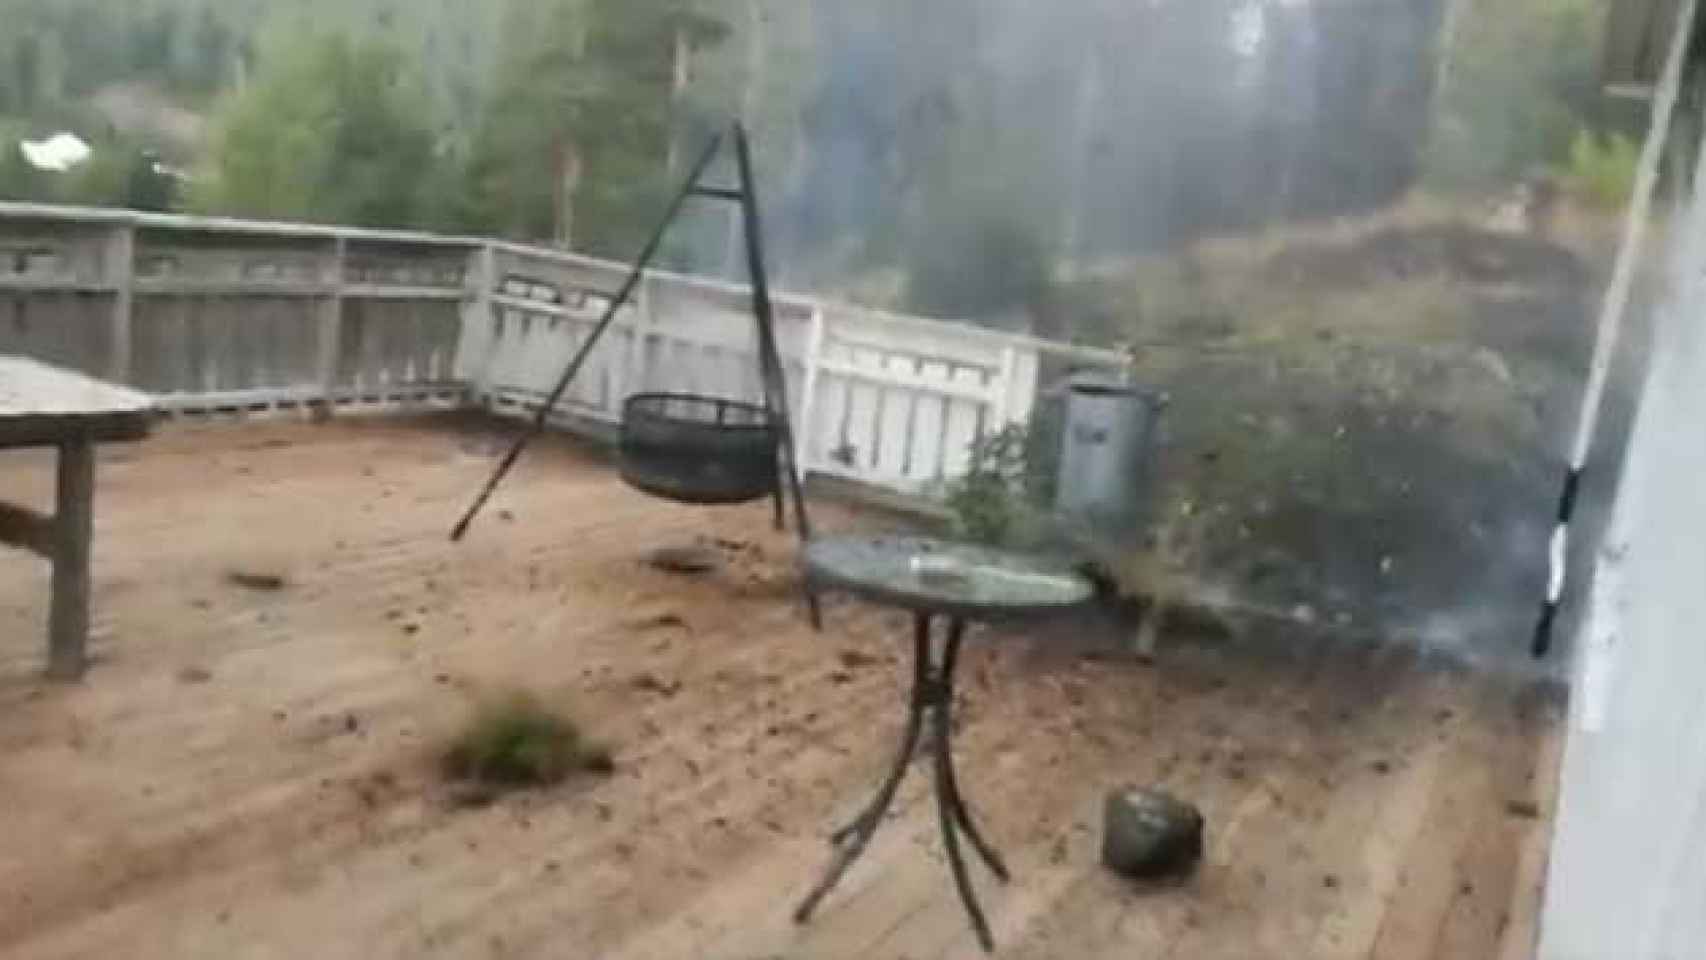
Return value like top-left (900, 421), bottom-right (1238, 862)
top-left (1539, 92), bottom-right (1706, 960)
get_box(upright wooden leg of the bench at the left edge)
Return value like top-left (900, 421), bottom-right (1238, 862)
top-left (48, 440), bottom-right (96, 680)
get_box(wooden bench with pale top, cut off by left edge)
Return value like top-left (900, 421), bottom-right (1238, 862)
top-left (0, 355), bottom-right (155, 680)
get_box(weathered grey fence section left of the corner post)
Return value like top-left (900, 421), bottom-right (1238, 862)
top-left (0, 205), bottom-right (479, 414)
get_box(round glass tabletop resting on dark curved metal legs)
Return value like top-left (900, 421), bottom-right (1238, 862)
top-left (804, 535), bottom-right (1092, 619)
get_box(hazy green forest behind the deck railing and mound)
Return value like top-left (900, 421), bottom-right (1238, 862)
top-left (0, 0), bottom-right (1639, 310)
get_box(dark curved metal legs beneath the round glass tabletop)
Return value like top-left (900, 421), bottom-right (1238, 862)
top-left (793, 614), bottom-right (1008, 950)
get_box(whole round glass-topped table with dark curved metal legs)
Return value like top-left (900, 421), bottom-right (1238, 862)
top-left (793, 537), bottom-right (1092, 950)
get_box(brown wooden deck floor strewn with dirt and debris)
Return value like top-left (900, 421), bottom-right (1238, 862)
top-left (0, 421), bottom-right (1559, 960)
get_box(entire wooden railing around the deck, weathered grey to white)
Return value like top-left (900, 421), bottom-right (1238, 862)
top-left (0, 203), bottom-right (1123, 491)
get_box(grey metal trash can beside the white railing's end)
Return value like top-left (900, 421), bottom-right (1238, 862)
top-left (1054, 375), bottom-right (1162, 532)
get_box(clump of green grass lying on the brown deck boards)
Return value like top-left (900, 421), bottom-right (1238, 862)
top-left (440, 691), bottom-right (616, 788)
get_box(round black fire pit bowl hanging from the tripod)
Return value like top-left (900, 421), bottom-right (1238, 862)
top-left (621, 394), bottom-right (778, 503)
